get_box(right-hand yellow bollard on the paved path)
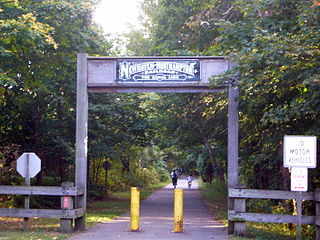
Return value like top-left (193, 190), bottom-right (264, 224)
top-left (173, 189), bottom-right (183, 233)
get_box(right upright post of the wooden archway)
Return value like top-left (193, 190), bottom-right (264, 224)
top-left (228, 76), bottom-right (239, 234)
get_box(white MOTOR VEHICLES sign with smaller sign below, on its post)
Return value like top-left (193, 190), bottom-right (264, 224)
top-left (283, 135), bottom-right (317, 240)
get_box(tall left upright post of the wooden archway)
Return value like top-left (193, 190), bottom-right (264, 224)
top-left (75, 53), bottom-right (88, 231)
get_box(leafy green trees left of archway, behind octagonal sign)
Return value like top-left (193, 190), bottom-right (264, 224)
top-left (0, 0), bottom-right (111, 185)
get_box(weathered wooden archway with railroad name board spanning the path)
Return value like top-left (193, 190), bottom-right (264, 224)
top-left (75, 53), bottom-right (238, 230)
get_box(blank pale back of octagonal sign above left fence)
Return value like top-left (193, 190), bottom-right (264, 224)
top-left (17, 153), bottom-right (41, 178)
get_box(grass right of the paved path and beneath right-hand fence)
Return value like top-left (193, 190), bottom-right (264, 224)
top-left (200, 181), bottom-right (314, 240)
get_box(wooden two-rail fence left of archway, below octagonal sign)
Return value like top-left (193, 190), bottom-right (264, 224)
top-left (0, 182), bottom-right (84, 232)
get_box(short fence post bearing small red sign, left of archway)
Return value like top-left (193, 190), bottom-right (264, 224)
top-left (60, 182), bottom-right (74, 233)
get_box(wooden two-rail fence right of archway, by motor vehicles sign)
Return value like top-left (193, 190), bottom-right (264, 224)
top-left (228, 187), bottom-right (320, 240)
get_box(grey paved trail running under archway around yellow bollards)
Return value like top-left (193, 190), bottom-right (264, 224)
top-left (70, 179), bottom-right (227, 240)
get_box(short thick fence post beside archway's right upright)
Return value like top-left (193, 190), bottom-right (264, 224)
top-left (234, 184), bottom-right (246, 236)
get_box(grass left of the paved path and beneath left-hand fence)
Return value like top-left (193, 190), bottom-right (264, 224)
top-left (0, 183), bottom-right (168, 240)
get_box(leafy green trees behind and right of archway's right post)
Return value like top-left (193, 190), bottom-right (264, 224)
top-left (131, 0), bottom-right (320, 190)
